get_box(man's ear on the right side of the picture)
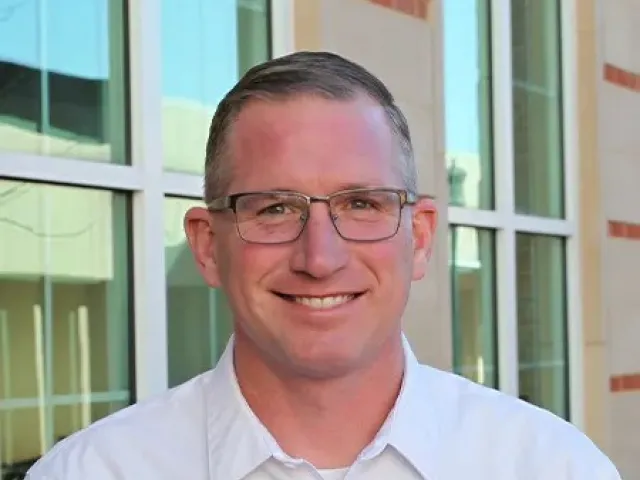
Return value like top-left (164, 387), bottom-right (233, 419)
top-left (412, 196), bottom-right (438, 280)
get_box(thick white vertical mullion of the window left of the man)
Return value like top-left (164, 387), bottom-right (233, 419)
top-left (128, 0), bottom-right (168, 400)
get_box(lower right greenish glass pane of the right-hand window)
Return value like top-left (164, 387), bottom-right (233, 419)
top-left (516, 234), bottom-right (569, 418)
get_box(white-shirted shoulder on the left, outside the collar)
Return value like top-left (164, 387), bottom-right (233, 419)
top-left (27, 373), bottom-right (208, 480)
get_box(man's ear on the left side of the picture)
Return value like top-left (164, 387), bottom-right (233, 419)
top-left (184, 207), bottom-right (220, 288)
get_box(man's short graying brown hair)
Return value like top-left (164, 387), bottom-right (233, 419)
top-left (204, 51), bottom-right (417, 203)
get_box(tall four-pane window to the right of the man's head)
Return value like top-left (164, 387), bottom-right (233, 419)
top-left (444, 0), bottom-right (580, 419)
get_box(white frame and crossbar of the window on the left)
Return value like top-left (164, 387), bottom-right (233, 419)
top-left (0, 0), bottom-right (282, 402)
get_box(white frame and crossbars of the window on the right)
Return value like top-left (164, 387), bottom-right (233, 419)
top-left (448, 0), bottom-right (584, 428)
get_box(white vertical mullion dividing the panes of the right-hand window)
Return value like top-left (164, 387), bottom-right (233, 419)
top-left (491, 0), bottom-right (518, 395)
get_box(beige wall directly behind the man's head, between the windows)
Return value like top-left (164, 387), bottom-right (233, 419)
top-left (294, 0), bottom-right (452, 368)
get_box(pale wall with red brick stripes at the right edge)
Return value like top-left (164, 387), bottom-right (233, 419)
top-left (597, 0), bottom-right (640, 478)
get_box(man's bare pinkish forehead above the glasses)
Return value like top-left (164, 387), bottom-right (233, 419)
top-left (229, 96), bottom-right (402, 194)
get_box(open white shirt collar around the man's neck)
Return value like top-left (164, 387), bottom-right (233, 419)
top-left (206, 335), bottom-right (446, 480)
